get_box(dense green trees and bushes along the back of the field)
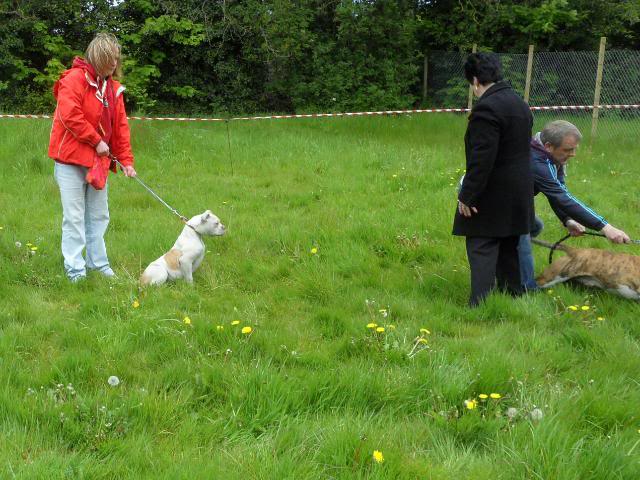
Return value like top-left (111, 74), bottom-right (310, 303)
top-left (0, 0), bottom-right (640, 115)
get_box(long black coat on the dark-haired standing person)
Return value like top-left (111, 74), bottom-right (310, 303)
top-left (453, 82), bottom-right (534, 237)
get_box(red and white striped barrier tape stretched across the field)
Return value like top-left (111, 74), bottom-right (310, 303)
top-left (0, 105), bottom-right (640, 122)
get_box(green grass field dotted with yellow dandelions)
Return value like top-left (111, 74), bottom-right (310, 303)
top-left (0, 115), bottom-right (640, 480)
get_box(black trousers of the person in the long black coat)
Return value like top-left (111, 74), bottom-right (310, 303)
top-left (466, 235), bottom-right (523, 307)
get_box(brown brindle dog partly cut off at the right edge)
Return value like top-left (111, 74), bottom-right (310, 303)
top-left (531, 238), bottom-right (640, 300)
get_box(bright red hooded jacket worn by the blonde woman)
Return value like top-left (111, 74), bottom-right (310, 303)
top-left (49, 58), bottom-right (133, 167)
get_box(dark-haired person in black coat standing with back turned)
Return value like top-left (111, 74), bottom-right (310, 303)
top-left (453, 53), bottom-right (534, 306)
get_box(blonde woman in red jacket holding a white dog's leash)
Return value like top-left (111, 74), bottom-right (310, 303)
top-left (49, 33), bottom-right (136, 282)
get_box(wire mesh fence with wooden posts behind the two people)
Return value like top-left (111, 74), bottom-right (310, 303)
top-left (424, 46), bottom-right (640, 142)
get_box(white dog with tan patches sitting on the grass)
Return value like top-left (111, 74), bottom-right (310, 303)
top-left (140, 210), bottom-right (225, 286)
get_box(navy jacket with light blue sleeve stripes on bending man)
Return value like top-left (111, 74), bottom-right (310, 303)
top-left (531, 134), bottom-right (607, 230)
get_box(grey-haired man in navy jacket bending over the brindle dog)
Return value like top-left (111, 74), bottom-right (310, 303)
top-left (518, 120), bottom-right (630, 290)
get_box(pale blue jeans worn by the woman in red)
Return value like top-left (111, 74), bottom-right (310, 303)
top-left (54, 162), bottom-right (111, 280)
